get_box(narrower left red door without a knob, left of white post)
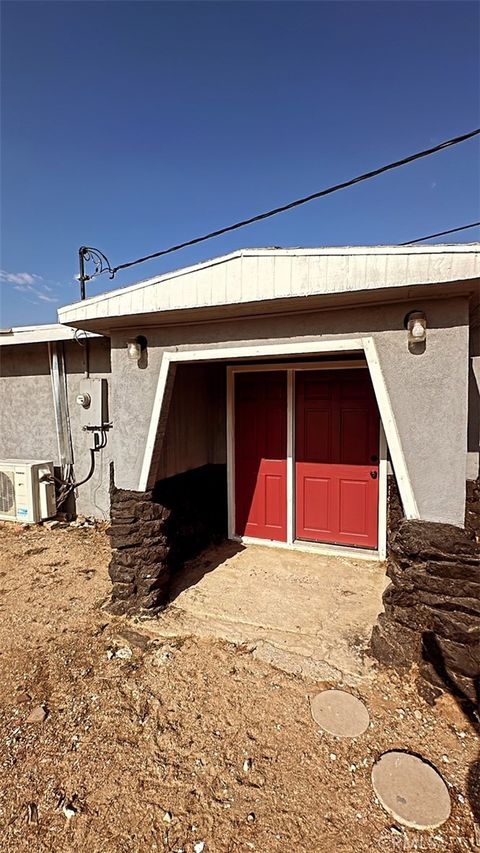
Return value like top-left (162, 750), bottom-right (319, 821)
top-left (235, 371), bottom-right (287, 542)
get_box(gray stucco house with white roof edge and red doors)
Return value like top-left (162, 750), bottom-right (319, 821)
top-left (0, 244), bottom-right (480, 696)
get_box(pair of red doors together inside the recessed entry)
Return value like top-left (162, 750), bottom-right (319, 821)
top-left (235, 370), bottom-right (379, 548)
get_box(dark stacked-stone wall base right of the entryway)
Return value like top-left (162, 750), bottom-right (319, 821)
top-left (371, 519), bottom-right (480, 705)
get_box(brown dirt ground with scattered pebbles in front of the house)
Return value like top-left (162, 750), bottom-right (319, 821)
top-left (0, 524), bottom-right (480, 853)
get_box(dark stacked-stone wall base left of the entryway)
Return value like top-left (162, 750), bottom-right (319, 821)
top-left (108, 465), bottom-right (227, 615)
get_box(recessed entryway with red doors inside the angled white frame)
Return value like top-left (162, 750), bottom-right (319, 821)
top-left (142, 353), bottom-right (387, 559)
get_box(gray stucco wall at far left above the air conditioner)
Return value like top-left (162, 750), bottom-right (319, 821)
top-left (0, 338), bottom-right (112, 518)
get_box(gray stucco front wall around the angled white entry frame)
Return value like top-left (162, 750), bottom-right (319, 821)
top-left (111, 297), bottom-right (469, 525)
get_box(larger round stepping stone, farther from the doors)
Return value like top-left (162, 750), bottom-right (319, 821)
top-left (372, 751), bottom-right (451, 829)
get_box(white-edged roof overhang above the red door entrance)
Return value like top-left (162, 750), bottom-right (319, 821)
top-left (58, 243), bottom-right (480, 332)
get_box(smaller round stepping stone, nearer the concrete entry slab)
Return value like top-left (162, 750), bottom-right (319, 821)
top-left (310, 690), bottom-right (370, 737)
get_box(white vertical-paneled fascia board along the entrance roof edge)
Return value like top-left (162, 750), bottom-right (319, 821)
top-left (58, 243), bottom-right (480, 330)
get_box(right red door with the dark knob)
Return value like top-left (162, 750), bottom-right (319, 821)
top-left (295, 370), bottom-right (379, 548)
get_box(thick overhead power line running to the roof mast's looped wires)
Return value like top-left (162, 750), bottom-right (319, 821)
top-left (79, 123), bottom-right (480, 290)
